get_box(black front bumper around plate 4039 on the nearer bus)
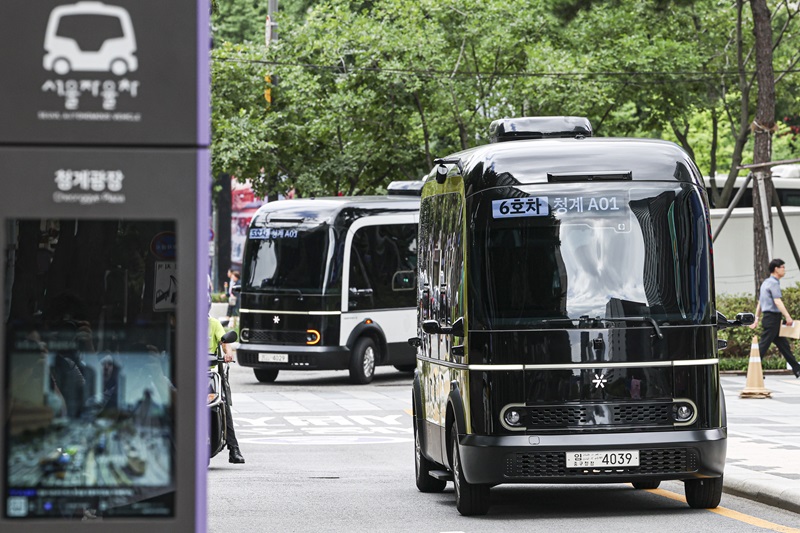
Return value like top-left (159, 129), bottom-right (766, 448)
top-left (458, 428), bottom-right (727, 485)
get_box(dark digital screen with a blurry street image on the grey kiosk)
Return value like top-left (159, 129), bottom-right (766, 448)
top-left (2, 219), bottom-right (179, 520)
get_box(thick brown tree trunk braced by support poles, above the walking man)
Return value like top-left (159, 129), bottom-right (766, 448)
top-left (750, 0), bottom-right (775, 291)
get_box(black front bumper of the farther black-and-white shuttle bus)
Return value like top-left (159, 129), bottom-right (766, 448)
top-left (236, 344), bottom-right (350, 370)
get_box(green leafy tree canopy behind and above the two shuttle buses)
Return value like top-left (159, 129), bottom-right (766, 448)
top-left (212, 0), bottom-right (800, 202)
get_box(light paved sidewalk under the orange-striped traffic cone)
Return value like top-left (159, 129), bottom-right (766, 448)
top-left (721, 373), bottom-right (800, 513)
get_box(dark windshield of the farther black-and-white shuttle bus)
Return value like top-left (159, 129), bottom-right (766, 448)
top-left (242, 224), bottom-right (341, 295)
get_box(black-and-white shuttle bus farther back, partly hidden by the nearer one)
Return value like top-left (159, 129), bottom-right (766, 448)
top-left (237, 182), bottom-right (421, 383)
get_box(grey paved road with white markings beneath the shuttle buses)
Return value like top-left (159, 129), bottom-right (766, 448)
top-left (208, 366), bottom-right (800, 533)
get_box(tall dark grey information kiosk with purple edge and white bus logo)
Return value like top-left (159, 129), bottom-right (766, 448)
top-left (0, 0), bottom-right (210, 533)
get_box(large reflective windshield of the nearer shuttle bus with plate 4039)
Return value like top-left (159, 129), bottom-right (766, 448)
top-left (467, 182), bottom-right (713, 329)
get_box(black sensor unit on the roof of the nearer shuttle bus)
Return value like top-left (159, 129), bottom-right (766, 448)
top-left (489, 117), bottom-right (592, 143)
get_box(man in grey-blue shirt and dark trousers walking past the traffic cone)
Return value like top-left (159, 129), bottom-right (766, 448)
top-left (750, 259), bottom-right (800, 378)
